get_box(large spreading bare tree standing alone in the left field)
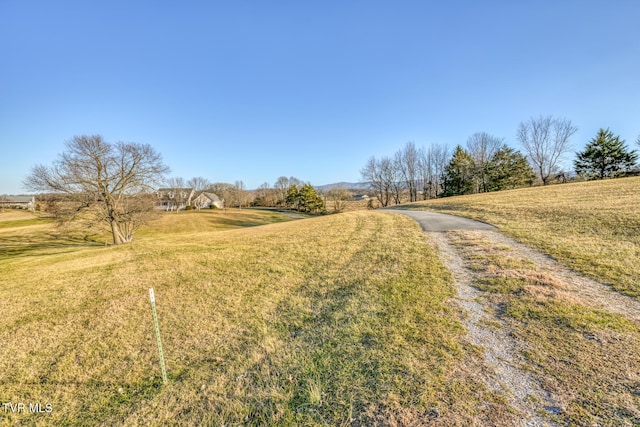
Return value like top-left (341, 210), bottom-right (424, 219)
top-left (24, 135), bottom-right (169, 245)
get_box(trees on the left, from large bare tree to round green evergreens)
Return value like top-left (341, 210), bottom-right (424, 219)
top-left (23, 135), bottom-right (324, 245)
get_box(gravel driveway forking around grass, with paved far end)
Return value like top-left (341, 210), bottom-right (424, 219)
top-left (384, 209), bottom-right (640, 427)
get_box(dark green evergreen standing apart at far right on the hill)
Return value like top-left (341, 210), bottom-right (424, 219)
top-left (574, 129), bottom-right (638, 179)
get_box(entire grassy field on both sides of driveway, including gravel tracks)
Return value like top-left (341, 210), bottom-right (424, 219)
top-left (0, 179), bottom-right (640, 426)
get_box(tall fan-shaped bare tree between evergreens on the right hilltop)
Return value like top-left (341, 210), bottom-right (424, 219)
top-left (517, 116), bottom-right (578, 185)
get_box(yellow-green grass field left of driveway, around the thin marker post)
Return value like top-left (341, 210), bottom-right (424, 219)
top-left (0, 211), bottom-right (513, 426)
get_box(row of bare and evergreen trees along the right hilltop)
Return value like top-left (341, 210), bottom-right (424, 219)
top-left (360, 116), bottom-right (640, 206)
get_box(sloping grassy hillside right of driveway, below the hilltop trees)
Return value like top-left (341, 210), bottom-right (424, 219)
top-left (404, 177), bottom-right (640, 298)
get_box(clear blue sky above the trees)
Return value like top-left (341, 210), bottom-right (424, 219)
top-left (0, 0), bottom-right (640, 194)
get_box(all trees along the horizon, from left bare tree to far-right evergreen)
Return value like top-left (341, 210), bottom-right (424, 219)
top-left (23, 125), bottom-right (640, 244)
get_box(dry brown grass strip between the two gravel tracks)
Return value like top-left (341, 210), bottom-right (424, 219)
top-left (454, 232), bottom-right (640, 426)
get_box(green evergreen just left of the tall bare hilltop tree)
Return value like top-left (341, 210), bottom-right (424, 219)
top-left (485, 145), bottom-right (536, 191)
